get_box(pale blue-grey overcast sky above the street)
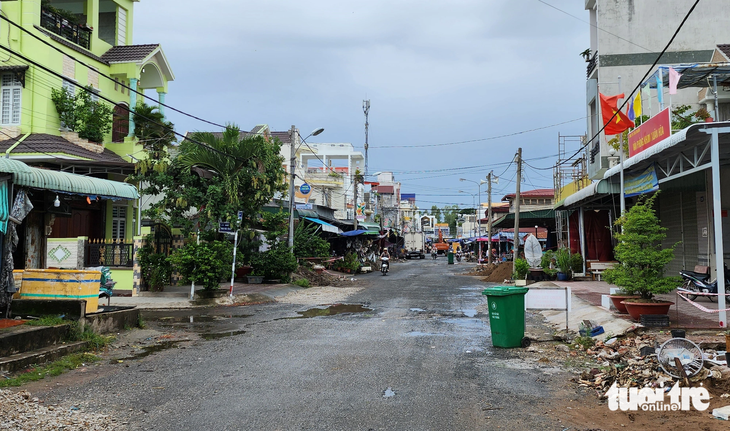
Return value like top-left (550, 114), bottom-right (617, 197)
top-left (134, 0), bottom-right (589, 209)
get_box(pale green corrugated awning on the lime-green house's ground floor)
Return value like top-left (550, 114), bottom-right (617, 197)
top-left (0, 157), bottom-right (139, 200)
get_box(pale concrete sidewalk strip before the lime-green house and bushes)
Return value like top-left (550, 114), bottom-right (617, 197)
top-left (109, 282), bottom-right (302, 309)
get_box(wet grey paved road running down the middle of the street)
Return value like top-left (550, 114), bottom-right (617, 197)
top-left (28, 259), bottom-right (574, 430)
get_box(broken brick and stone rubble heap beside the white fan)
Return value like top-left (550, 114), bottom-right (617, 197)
top-left (576, 334), bottom-right (730, 397)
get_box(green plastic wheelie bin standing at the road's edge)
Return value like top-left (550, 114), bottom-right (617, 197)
top-left (482, 286), bottom-right (529, 347)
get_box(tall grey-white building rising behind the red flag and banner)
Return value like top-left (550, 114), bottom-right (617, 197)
top-left (585, 0), bottom-right (730, 180)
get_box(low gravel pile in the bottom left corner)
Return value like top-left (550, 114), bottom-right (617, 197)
top-left (0, 390), bottom-right (115, 431)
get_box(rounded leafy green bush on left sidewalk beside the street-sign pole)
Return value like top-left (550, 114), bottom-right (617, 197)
top-left (169, 241), bottom-right (233, 290)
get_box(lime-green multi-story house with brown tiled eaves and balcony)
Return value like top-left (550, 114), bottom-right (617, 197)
top-left (0, 0), bottom-right (174, 291)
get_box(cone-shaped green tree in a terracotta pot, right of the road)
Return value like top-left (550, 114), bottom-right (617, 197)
top-left (604, 194), bottom-right (681, 321)
